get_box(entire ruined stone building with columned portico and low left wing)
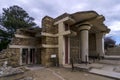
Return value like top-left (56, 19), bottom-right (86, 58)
top-left (0, 11), bottom-right (110, 66)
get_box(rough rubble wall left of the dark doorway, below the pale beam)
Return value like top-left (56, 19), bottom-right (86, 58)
top-left (0, 48), bottom-right (20, 67)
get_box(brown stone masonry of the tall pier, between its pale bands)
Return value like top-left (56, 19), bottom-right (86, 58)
top-left (41, 16), bottom-right (58, 66)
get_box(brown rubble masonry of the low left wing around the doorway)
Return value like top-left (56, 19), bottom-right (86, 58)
top-left (0, 30), bottom-right (41, 66)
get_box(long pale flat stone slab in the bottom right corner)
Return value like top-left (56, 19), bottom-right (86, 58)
top-left (89, 69), bottom-right (120, 79)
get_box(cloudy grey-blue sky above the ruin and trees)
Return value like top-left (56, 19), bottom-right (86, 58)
top-left (0, 0), bottom-right (120, 43)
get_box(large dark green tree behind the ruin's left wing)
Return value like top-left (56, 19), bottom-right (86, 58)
top-left (0, 5), bottom-right (36, 51)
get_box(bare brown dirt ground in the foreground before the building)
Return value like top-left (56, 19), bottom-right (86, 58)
top-left (0, 67), bottom-right (115, 80)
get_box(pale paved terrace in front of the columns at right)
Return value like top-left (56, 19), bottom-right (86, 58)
top-left (64, 60), bottom-right (120, 79)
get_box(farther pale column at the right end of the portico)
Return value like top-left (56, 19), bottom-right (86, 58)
top-left (96, 33), bottom-right (105, 57)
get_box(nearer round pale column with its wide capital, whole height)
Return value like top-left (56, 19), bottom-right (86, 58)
top-left (79, 25), bottom-right (91, 62)
